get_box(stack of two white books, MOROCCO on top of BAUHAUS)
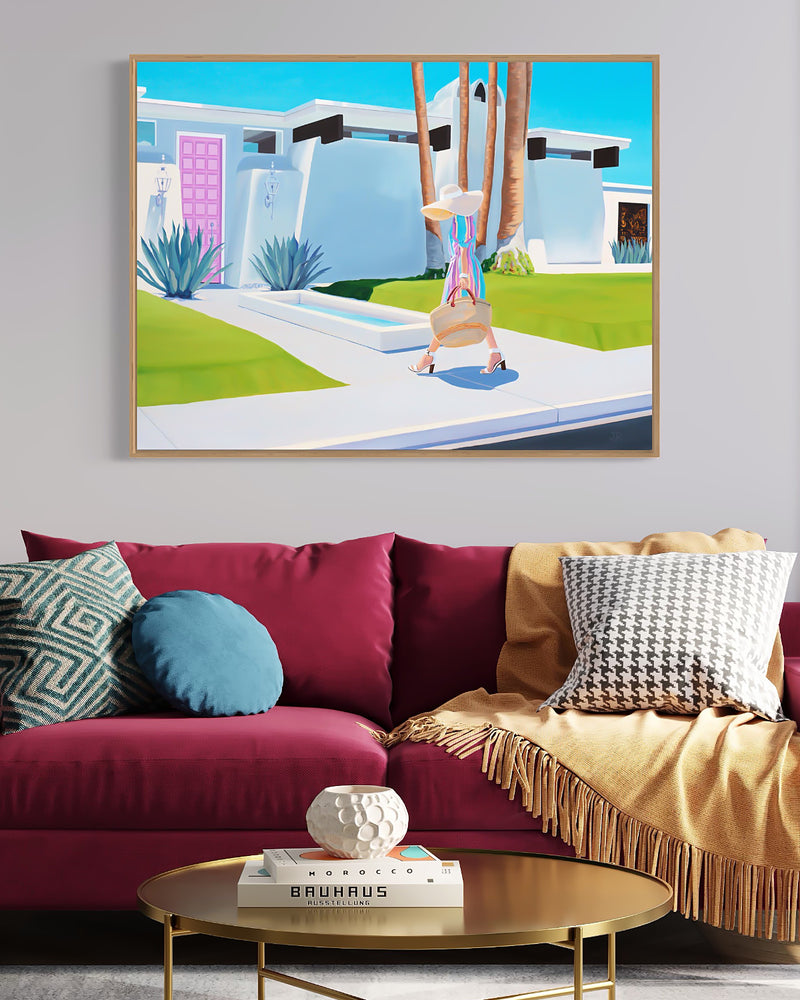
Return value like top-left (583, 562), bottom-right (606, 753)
top-left (237, 844), bottom-right (464, 908)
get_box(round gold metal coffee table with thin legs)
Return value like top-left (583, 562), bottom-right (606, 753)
top-left (138, 850), bottom-right (672, 1000)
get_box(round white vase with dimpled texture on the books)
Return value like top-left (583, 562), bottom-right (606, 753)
top-left (306, 785), bottom-right (408, 858)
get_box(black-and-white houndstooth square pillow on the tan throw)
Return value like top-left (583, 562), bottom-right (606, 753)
top-left (541, 552), bottom-right (796, 722)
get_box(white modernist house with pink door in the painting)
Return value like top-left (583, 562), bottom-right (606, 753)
top-left (137, 80), bottom-right (652, 287)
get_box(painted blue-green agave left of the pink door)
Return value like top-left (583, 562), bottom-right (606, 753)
top-left (136, 222), bottom-right (230, 299)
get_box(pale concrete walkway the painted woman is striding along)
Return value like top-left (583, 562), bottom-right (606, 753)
top-left (138, 289), bottom-right (652, 451)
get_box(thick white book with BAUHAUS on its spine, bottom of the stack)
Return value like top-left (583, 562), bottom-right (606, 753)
top-left (237, 858), bottom-right (464, 909)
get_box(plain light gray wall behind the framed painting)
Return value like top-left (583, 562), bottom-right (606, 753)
top-left (0, 0), bottom-right (800, 592)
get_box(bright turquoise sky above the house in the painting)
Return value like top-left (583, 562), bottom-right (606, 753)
top-left (137, 61), bottom-right (653, 184)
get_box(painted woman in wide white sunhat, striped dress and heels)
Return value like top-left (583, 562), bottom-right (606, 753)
top-left (408, 184), bottom-right (506, 375)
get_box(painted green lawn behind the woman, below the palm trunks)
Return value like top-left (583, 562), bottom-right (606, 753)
top-left (318, 271), bottom-right (653, 351)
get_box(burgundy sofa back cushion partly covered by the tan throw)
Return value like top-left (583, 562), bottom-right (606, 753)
top-left (392, 535), bottom-right (511, 724)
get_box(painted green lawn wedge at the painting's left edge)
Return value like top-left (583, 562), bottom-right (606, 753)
top-left (136, 291), bottom-right (345, 406)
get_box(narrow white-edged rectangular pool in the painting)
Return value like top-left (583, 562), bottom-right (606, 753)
top-left (239, 290), bottom-right (431, 351)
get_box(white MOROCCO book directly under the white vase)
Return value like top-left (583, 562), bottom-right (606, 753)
top-left (264, 844), bottom-right (450, 883)
